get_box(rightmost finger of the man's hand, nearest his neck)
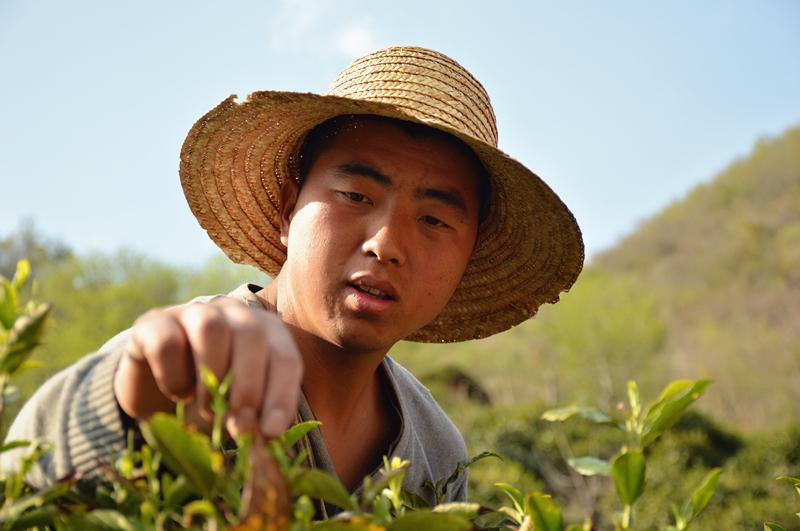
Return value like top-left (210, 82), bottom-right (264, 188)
top-left (261, 314), bottom-right (303, 439)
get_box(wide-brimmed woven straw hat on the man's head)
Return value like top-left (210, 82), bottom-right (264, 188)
top-left (180, 46), bottom-right (583, 342)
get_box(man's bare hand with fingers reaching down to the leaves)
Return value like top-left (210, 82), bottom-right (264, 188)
top-left (114, 297), bottom-right (303, 438)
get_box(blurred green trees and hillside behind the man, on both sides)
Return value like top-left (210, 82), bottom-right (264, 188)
top-left (0, 124), bottom-right (800, 529)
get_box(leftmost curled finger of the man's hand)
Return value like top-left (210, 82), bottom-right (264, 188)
top-left (129, 312), bottom-right (195, 401)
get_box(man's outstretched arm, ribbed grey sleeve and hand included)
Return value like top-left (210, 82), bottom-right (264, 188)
top-left (0, 296), bottom-right (302, 485)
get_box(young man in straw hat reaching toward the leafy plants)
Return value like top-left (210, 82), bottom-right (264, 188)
top-left (4, 47), bottom-right (583, 500)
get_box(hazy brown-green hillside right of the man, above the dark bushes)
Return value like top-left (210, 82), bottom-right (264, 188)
top-left (395, 128), bottom-right (800, 429)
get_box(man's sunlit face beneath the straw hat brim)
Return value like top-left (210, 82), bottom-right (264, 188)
top-left (278, 118), bottom-right (479, 351)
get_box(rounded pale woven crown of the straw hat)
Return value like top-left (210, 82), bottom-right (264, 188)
top-left (327, 46), bottom-right (497, 147)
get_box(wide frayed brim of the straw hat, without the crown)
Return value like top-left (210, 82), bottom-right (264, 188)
top-left (180, 91), bottom-right (584, 342)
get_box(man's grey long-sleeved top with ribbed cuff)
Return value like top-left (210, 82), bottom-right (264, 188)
top-left (0, 285), bottom-right (467, 504)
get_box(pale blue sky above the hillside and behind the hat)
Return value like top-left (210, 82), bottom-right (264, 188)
top-left (0, 0), bottom-right (800, 265)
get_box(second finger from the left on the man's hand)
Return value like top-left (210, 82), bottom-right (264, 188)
top-left (180, 303), bottom-right (231, 419)
